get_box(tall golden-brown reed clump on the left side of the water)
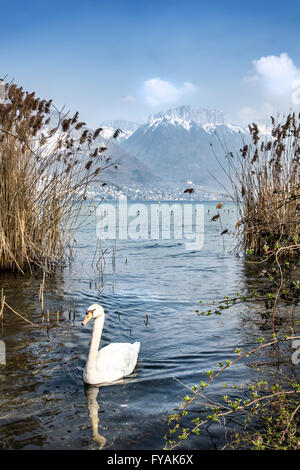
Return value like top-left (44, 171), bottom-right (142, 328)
top-left (0, 84), bottom-right (113, 272)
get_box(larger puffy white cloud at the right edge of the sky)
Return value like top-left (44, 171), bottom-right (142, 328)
top-left (253, 52), bottom-right (300, 101)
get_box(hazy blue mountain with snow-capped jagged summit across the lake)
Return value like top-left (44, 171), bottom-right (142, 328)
top-left (121, 106), bottom-right (249, 189)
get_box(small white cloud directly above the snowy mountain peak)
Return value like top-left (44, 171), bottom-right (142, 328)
top-left (144, 78), bottom-right (196, 106)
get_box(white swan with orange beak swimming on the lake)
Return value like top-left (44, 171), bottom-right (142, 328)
top-left (82, 304), bottom-right (140, 385)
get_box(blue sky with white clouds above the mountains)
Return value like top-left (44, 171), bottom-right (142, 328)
top-left (0, 0), bottom-right (300, 127)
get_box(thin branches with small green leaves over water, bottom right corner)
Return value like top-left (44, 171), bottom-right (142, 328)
top-left (164, 336), bottom-right (300, 450)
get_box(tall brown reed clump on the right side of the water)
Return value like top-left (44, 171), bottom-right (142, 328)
top-left (227, 113), bottom-right (300, 256)
